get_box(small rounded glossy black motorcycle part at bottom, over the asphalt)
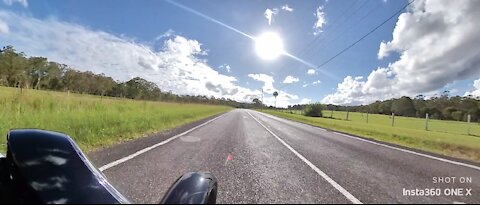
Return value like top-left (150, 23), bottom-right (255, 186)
top-left (160, 172), bottom-right (217, 204)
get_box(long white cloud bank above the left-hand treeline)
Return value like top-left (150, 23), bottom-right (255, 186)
top-left (0, 11), bottom-right (261, 102)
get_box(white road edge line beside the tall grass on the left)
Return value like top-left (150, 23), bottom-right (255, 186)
top-left (99, 114), bottom-right (224, 172)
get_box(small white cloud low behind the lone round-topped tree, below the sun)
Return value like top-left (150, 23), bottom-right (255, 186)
top-left (248, 74), bottom-right (298, 107)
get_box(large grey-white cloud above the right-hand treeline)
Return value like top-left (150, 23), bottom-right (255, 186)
top-left (322, 0), bottom-right (480, 104)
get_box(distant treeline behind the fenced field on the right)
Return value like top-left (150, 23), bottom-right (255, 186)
top-left (288, 91), bottom-right (480, 122)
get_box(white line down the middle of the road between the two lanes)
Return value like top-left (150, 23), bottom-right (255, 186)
top-left (247, 111), bottom-right (362, 204)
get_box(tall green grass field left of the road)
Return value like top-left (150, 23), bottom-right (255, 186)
top-left (0, 87), bottom-right (231, 153)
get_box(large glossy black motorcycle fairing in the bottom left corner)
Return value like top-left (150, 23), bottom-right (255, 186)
top-left (4, 129), bottom-right (128, 203)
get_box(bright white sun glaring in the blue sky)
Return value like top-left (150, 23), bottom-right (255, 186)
top-left (255, 32), bottom-right (283, 60)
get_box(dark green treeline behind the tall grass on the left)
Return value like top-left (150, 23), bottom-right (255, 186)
top-left (0, 46), bottom-right (252, 108)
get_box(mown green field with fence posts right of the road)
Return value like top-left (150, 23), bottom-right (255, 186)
top-left (263, 110), bottom-right (480, 162)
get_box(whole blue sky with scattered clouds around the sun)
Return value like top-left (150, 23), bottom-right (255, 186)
top-left (0, 0), bottom-right (480, 106)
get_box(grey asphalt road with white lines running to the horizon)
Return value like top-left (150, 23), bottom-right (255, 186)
top-left (89, 109), bottom-right (480, 203)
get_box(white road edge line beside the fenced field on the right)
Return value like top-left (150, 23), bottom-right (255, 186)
top-left (255, 110), bottom-right (480, 171)
